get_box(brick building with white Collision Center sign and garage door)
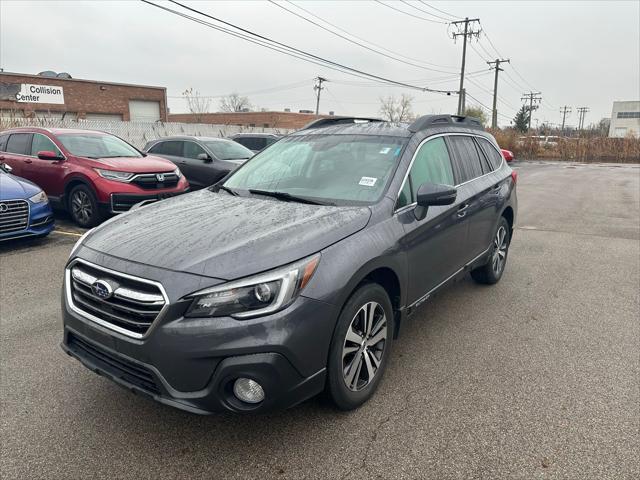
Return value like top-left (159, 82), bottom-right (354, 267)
top-left (0, 72), bottom-right (167, 122)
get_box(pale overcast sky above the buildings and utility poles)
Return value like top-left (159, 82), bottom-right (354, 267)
top-left (0, 0), bottom-right (640, 125)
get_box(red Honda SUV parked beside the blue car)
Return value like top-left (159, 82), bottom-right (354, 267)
top-left (0, 128), bottom-right (189, 227)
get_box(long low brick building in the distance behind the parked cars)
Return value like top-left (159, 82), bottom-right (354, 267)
top-left (169, 112), bottom-right (328, 130)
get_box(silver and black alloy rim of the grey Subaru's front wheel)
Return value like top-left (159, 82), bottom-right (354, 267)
top-left (342, 302), bottom-right (387, 391)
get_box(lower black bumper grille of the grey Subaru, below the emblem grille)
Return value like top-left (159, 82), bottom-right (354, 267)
top-left (67, 333), bottom-right (160, 395)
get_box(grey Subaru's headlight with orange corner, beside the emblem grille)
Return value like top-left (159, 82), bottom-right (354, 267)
top-left (185, 254), bottom-right (320, 319)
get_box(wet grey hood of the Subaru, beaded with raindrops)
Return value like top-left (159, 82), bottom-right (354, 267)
top-left (84, 189), bottom-right (371, 280)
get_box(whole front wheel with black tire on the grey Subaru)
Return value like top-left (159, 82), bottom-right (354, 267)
top-left (327, 283), bottom-right (393, 410)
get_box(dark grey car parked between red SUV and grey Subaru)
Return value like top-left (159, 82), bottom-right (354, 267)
top-left (144, 136), bottom-right (253, 190)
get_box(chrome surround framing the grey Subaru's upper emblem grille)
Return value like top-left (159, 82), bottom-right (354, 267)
top-left (64, 258), bottom-right (170, 340)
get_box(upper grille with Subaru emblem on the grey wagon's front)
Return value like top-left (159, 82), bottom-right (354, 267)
top-left (67, 262), bottom-right (167, 338)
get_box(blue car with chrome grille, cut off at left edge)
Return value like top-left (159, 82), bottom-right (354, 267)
top-left (0, 164), bottom-right (53, 242)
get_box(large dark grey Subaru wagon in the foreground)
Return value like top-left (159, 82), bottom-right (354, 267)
top-left (62, 115), bottom-right (517, 413)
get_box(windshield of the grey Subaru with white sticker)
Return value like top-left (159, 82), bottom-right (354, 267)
top-left (224, 135), bottom-right (407, 205)
